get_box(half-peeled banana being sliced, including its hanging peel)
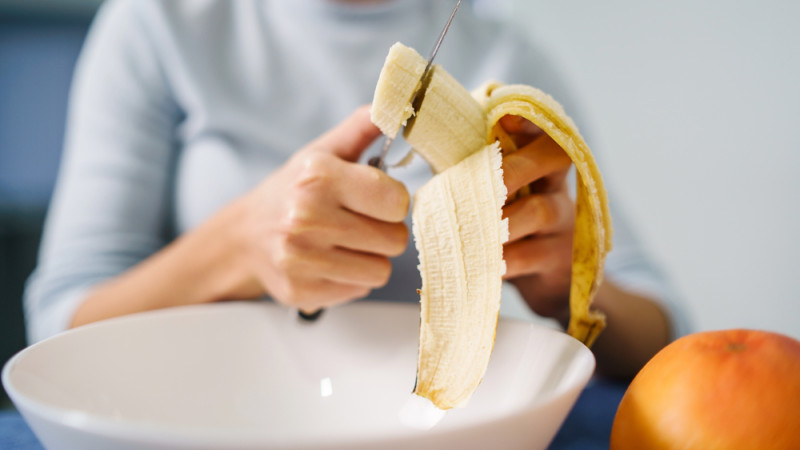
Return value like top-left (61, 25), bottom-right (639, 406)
top-left (372, 43), bottom-right (611, 409)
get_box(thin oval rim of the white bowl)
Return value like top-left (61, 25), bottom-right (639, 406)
top-left (0, 299), bottom-right (596, 448)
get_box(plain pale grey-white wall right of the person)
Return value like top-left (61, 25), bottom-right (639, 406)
top-left (510, 0), bottom-right (800, 338)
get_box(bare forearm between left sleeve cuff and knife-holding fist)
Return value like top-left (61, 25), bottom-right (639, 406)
top-left (71, 203), bottom-right (263, 327)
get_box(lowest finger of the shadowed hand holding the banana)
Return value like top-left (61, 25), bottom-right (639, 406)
top-left (503, 233), bottom-right (572, 279)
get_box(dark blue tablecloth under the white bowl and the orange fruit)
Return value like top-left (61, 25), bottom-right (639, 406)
top-left (0, 379), bottom-right (627, 450)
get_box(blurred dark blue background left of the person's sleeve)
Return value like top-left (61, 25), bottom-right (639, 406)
top-left (0, 0), bottom-right (100, 407)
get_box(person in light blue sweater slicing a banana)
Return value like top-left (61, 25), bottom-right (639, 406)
top-left (25, 0), bottom-right (680, 377)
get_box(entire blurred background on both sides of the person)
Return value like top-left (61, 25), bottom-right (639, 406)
top-left (0, 0), bottom-right (800, 402)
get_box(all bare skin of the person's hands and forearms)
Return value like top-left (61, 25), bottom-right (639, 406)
top-left (72, 106), bottom-right (668, 377)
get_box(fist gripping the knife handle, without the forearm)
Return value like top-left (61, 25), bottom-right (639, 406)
top-left (231, 106), bottom-right (409, 311)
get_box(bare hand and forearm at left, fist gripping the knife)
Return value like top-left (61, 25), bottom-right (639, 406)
top-left (71, 107), bottom-right (409, 326)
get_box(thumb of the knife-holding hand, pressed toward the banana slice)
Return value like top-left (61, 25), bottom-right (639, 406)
top-left (311, 105), bottom-right (381, 162)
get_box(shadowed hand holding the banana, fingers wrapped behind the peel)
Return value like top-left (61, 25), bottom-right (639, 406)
top-left (500, 116), bottom-right (575, 323)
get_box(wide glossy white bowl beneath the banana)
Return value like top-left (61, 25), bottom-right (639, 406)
top-left (3, 302), bottom-right (595, 449)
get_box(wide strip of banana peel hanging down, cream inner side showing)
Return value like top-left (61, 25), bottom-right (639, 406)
top-left (412, 144), bottom-right (508, 409)
